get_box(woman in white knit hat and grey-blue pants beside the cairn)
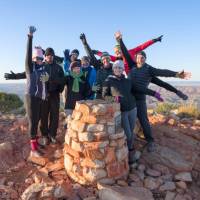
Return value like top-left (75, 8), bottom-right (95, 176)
top-left (102, 60), bottom-right (137, 164)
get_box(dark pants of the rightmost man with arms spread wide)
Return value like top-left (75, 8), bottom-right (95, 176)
top-left (136, 100), bottom-right (154, 142)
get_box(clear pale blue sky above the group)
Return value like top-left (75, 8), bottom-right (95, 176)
top-left (0, 0), bottom-right (200, 83)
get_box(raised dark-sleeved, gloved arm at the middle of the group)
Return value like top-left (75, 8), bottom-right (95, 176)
top-left (80, 33), bottom-right (101, 69)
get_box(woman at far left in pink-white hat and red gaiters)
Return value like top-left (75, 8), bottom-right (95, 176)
top-left (25, 26), bottom-right (49, 157)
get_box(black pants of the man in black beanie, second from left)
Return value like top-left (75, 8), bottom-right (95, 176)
top-left (40, 93), bottom-right (60, 137)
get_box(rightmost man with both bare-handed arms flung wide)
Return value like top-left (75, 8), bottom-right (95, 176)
top-left (115, 32), bottom-right (191, 152)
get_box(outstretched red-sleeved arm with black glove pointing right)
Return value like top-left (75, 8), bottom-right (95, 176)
top-left (129, 35), bottom-right (163, 58)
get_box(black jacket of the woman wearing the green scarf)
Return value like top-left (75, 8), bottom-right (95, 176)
top-left (65, 75), bottom-right (91, 109)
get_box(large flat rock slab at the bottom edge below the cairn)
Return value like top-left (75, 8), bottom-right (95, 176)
top-left (99, 186), bottom-right (154, 200)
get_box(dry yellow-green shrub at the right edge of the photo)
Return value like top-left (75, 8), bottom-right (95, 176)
top-left (178, 104), bottom-right (200, 119)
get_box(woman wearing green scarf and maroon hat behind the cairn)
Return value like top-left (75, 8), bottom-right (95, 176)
top-left (65, 61), bottom-right (91, 116)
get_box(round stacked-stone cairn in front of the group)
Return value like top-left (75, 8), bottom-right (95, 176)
top-left (64, 100), bottom-right (129, 185)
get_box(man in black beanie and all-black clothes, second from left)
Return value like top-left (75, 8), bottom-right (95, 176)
top-left (40, 48), bottom-right (64, 145)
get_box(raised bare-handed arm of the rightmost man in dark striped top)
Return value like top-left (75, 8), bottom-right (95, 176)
top-left (115, 31), bottom-right (136, 69)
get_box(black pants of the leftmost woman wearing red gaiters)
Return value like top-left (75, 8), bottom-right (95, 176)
top-left (25, 94), bottom-right (43, 139)
